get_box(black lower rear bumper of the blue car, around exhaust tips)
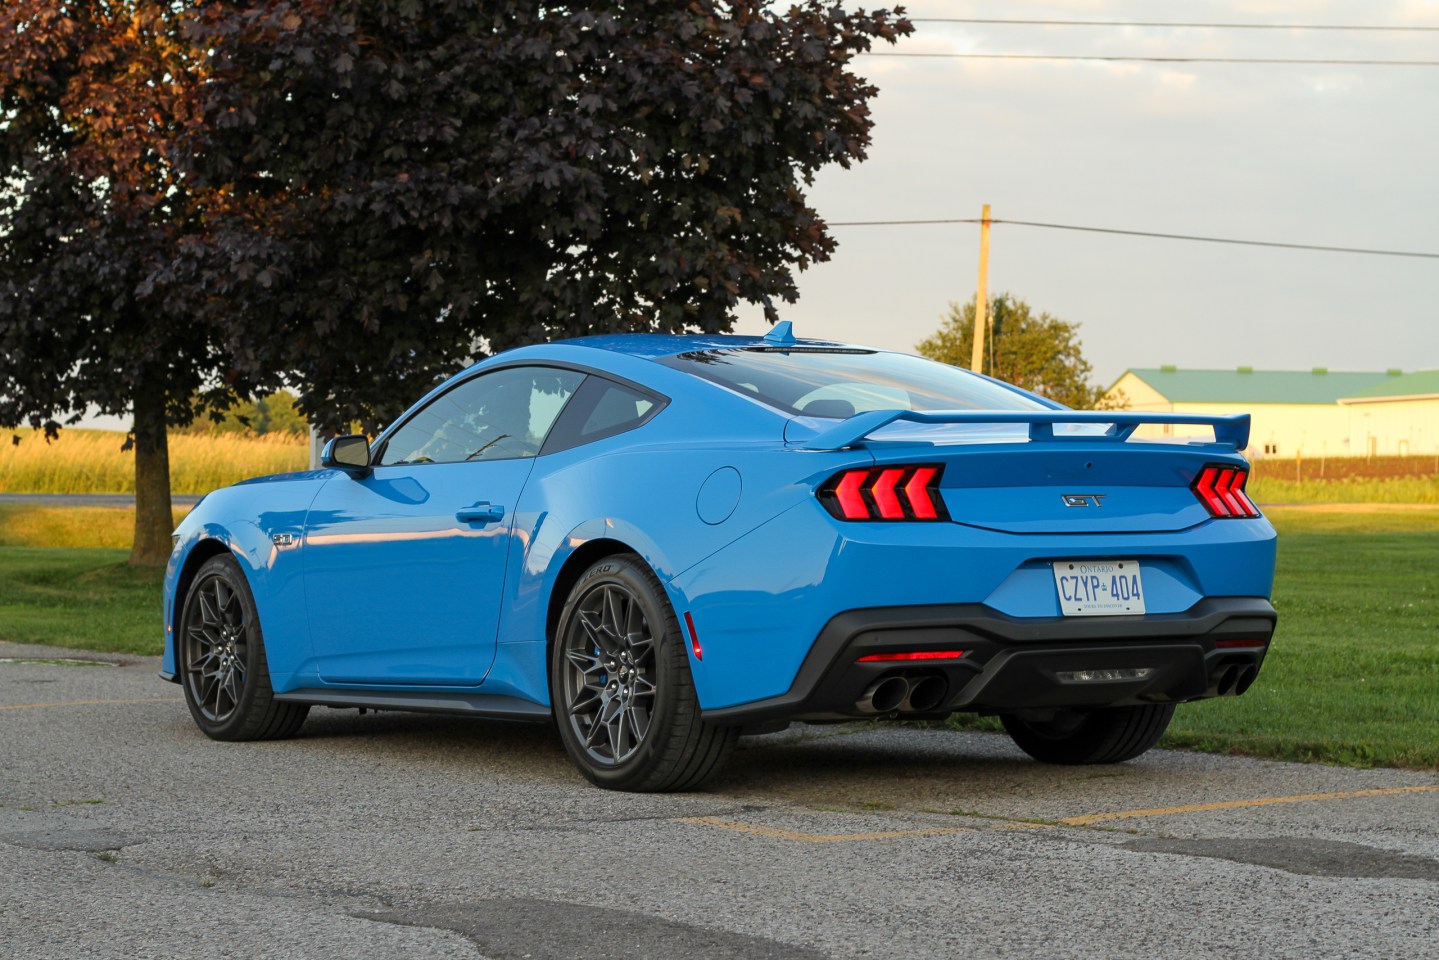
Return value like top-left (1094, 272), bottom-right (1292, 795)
top-left (704, 597), bottom-right (1276, 724)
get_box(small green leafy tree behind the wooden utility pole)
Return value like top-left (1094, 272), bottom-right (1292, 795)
top-left (915, 294), bottom-right (1104, 410)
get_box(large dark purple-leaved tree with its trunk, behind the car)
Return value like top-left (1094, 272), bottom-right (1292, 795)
top-left (0, 0), bottom-right (912, 563)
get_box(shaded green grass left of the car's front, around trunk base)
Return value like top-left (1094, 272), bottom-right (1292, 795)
top-left (0, 547), bottom-right (164, 655)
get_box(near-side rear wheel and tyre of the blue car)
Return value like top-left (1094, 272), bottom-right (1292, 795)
top-left (550, 554), bottom-right (740, 792)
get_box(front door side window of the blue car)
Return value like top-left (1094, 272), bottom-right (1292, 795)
top-left (378, 367), bottom-right (584, 466)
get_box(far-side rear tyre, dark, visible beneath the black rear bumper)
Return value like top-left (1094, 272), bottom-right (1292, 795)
top-left (1000, 704), bottom-right (1174, 766)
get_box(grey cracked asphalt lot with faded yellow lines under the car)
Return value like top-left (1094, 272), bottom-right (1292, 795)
top-left (0, 642), bottom-right (1439, 960)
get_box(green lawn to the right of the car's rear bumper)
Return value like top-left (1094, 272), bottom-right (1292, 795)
top-left (1163, 510), bottom-right (1439, 769)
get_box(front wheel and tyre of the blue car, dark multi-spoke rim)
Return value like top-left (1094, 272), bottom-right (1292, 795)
top-left (176, 554), bottom-right (309, 741)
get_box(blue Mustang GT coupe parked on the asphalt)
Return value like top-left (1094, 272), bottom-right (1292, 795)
top-left (163, 324), bottom-right (1275, 790)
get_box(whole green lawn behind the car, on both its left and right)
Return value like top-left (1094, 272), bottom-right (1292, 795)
top-left (0, 504), bottom-right (1439, 769)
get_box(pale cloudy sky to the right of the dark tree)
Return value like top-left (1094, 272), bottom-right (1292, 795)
top-left (738, 0), bottom-right (1439, 386)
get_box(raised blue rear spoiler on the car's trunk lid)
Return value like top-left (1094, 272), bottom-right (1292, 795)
top-left (800, 410), bottom-right (1249, 450)
